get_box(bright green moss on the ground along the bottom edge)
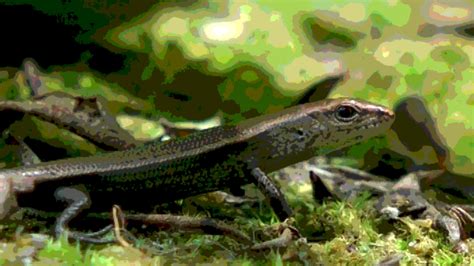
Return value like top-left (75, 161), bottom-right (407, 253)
top-left (0, 184), bottom-right (474, 265)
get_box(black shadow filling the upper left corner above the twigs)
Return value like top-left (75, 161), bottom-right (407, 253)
top-left (0, 4), bottom-right (125, 74)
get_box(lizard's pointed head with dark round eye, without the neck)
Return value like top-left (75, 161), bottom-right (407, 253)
top-left (305, 98), bottom-right (395, 152)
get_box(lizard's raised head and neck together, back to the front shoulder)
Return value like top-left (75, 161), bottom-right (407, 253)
top-left (238, 98), bottom-right (395, 171)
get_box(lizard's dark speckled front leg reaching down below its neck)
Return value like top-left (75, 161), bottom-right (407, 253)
top-left (250, 167), bottom-right (293, 221)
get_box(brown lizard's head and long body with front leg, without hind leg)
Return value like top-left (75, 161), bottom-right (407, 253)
top-left (0, 98), bottom-right (394, 241)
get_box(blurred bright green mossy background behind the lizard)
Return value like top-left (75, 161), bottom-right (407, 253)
top-left (0, 0), bottom-right (474, 176)
